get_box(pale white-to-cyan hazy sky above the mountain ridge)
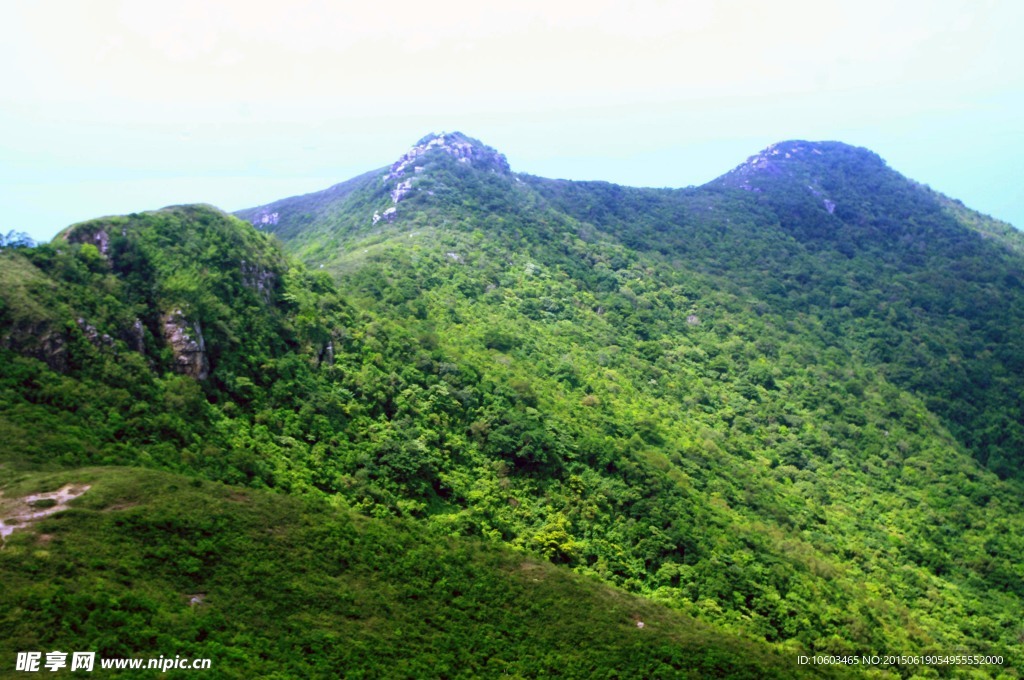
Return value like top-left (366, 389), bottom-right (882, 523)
top-left (0, 0), bottom-right (1024, 241)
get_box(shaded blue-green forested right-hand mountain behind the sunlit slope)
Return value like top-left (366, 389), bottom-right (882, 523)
top-left (534, 142), bottom-right (1024, 477)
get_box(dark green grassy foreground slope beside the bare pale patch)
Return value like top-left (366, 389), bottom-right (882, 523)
top-left (0, 461), bottom-right (823, 678)
